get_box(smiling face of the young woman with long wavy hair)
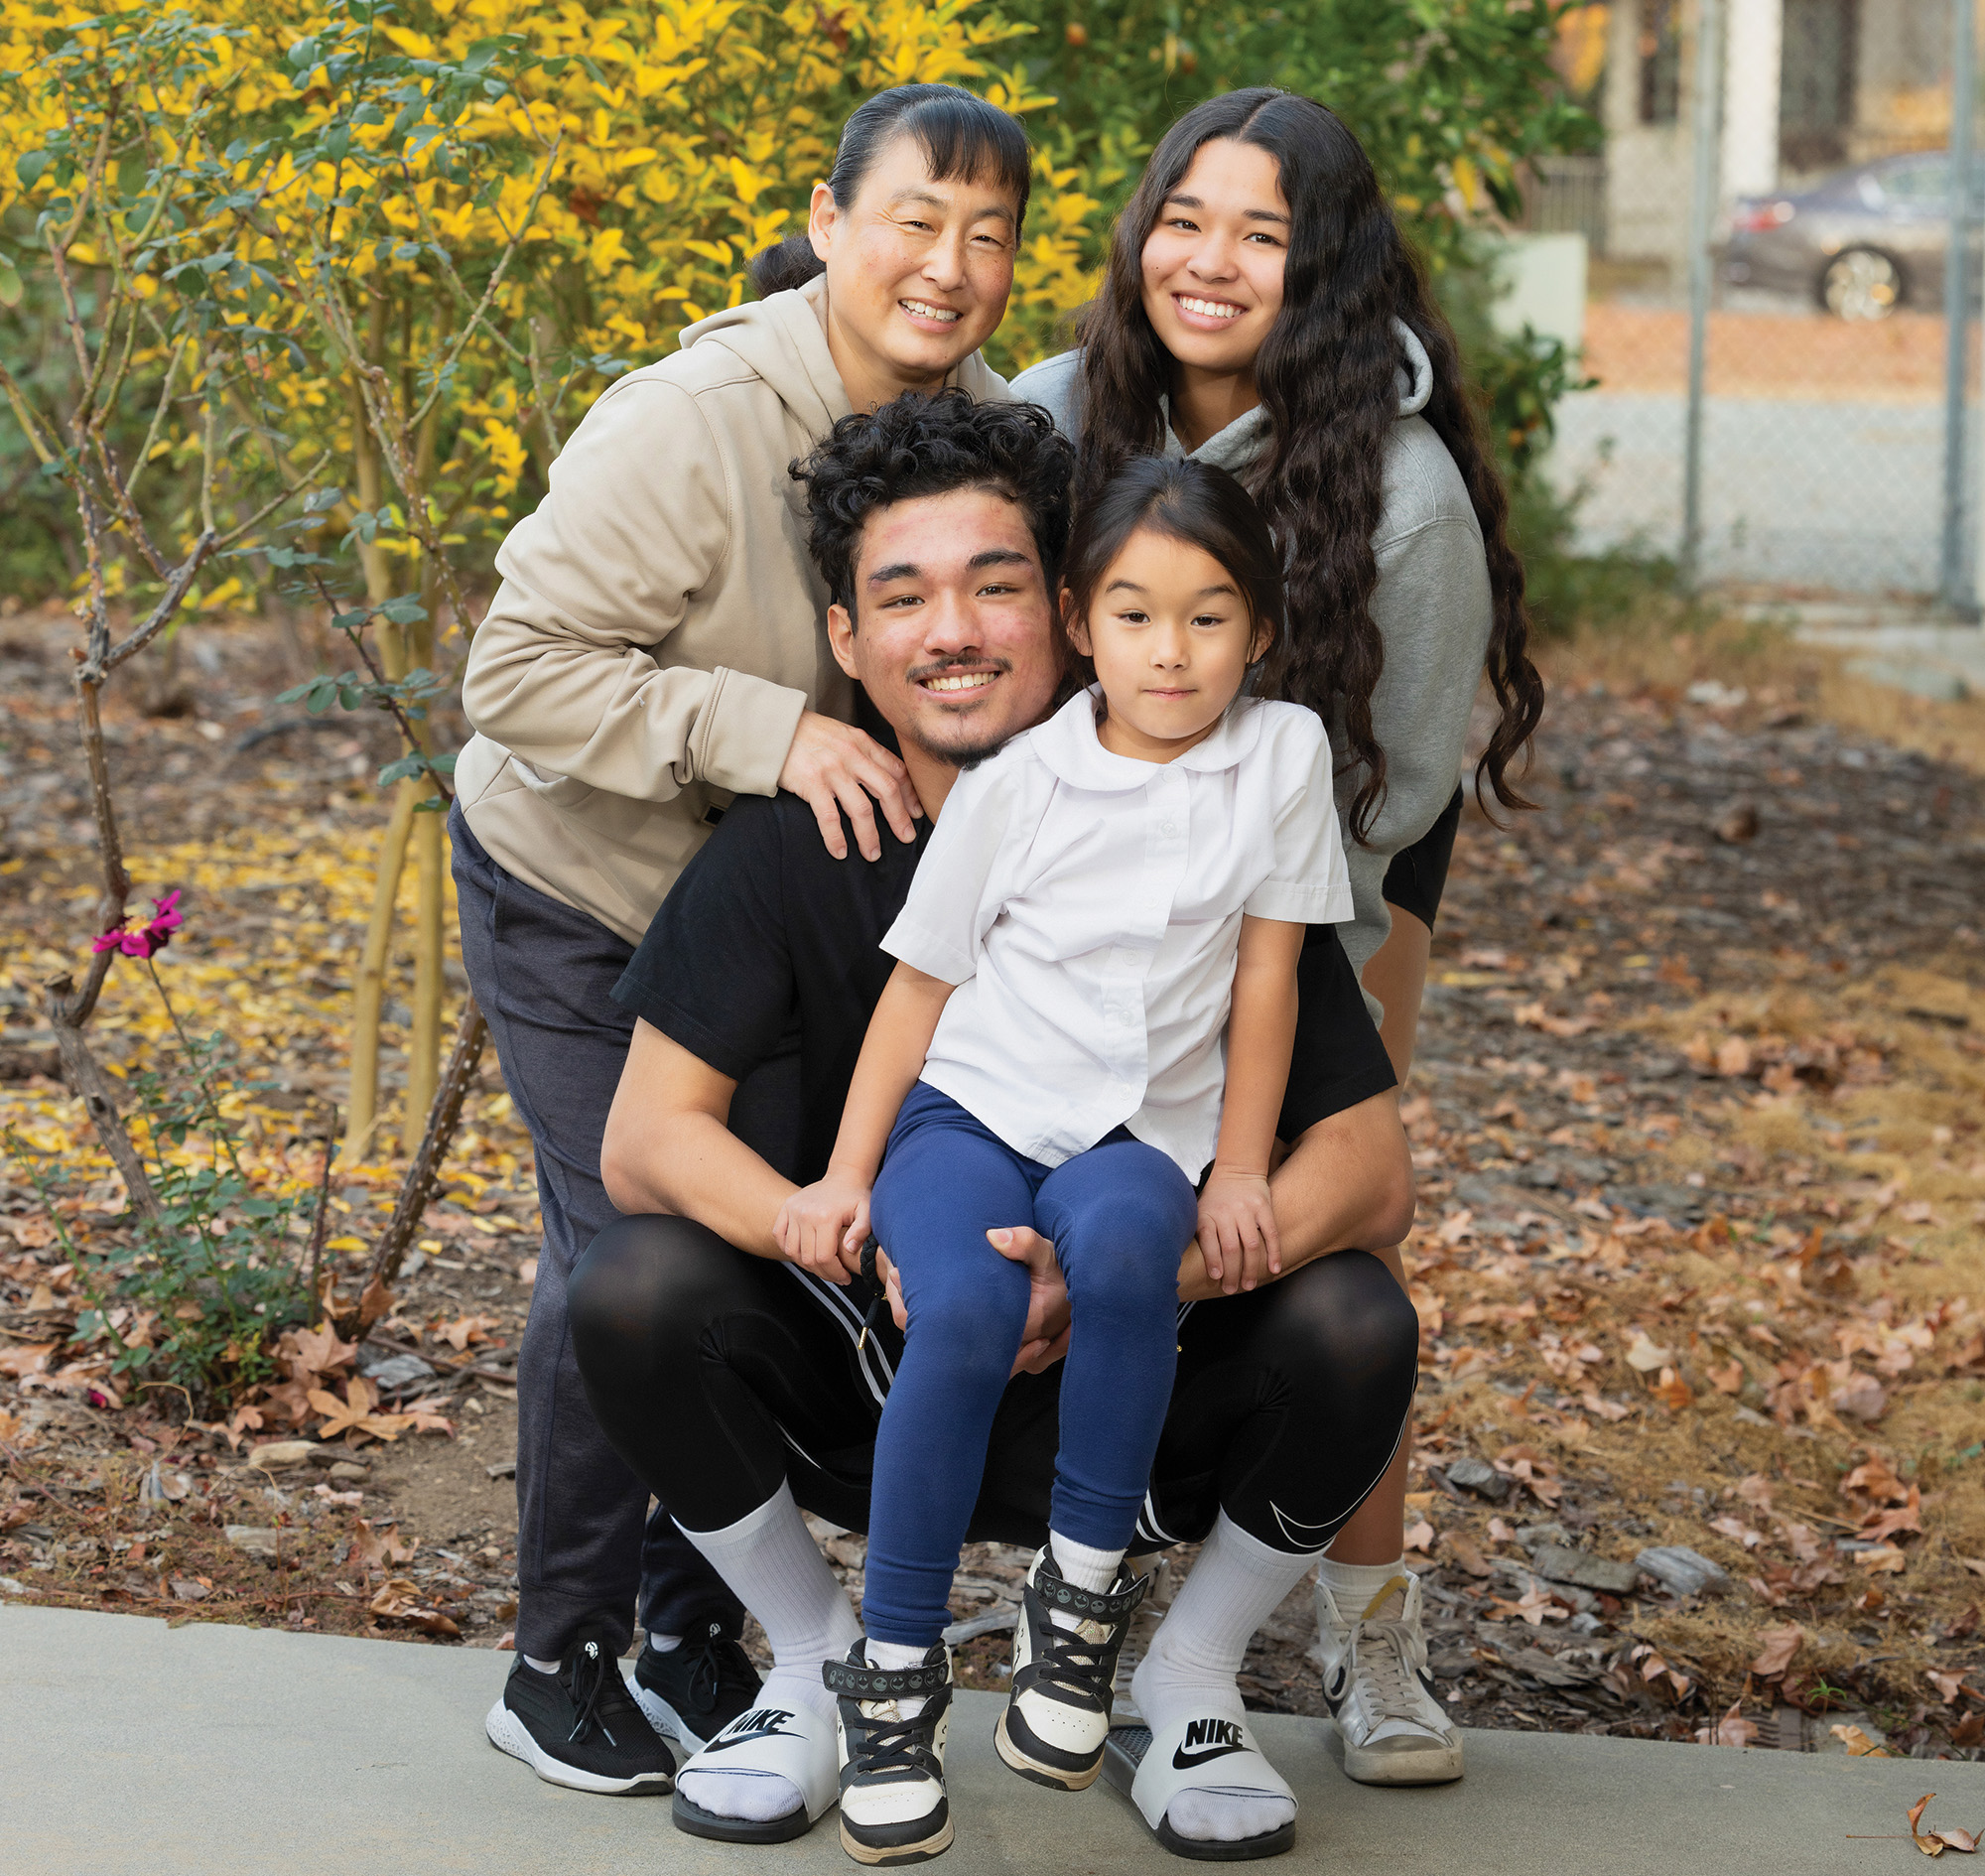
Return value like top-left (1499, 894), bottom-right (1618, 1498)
top-left (1143, 137), bottom-right (1288, 377)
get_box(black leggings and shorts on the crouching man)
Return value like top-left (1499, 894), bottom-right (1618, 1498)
top-left (570, 1217), bottom-right (1419, 1550)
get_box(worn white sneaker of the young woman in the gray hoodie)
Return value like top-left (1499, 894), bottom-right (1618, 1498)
top-left (1316, 1576), bottom-right (1463, 1785)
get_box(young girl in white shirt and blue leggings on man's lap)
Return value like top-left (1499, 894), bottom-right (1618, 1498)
top-left (776, 457), bottom-right (1352, 1862)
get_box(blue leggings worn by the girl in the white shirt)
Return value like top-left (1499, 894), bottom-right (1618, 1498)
top-left (861, 1082), bottom-right (1199, 1648)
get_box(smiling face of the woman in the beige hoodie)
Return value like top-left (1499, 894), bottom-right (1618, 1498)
top-left (808, 133), bottom-right (1020, 411)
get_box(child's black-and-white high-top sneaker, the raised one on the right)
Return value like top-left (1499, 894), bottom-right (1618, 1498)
top-left (992, 1544), bottom-right (1149, 1791)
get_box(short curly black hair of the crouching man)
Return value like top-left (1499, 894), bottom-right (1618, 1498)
top-left (790, 389), bottom-right (1076, 617)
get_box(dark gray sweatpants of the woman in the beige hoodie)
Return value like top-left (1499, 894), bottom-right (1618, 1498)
top-left (449, 808), bottom-right (744, 1660)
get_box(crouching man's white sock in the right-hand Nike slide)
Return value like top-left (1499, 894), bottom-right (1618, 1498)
top-left (1131, 1511), bottom-right (1316, 1842)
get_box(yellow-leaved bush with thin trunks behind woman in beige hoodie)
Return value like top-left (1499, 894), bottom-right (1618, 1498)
top-left (0, 0), bottom-right (1096, 1155)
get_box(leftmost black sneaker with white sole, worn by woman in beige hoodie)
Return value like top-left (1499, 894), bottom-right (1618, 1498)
top-left (482, 1638), bottom-right (675, 1799)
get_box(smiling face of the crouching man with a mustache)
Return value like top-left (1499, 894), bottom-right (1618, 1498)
top-left (828, 488), bottom-right (1062, 786)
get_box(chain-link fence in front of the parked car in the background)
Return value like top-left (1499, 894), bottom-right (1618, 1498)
top-left (1528, 0), bottom-right (1979, 600)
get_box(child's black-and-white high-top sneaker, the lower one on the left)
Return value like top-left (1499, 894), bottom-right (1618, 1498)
top-left (820, 1642), bottom-right (951, 1864)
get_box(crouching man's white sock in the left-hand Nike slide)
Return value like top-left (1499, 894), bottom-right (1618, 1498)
top-left (677, 1485), bottom-right (861, 1822)
